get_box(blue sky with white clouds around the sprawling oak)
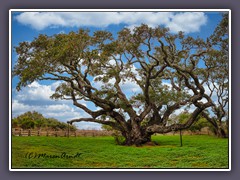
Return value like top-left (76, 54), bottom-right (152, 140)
top-left (11, 11), bottom-right (224, 129)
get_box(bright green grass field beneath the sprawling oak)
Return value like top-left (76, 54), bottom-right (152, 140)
top-left (12, 135), bottom-right (228, 168)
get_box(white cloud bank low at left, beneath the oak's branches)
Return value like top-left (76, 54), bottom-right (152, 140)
top-left (12, 81), bottom-right (98, 129)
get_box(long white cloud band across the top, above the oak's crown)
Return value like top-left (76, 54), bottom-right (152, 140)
top-left (16, 12), bottom-right (207, 33)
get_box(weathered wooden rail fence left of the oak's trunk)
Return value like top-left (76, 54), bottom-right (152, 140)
top-left (12, 128), bottom-right (112, 137)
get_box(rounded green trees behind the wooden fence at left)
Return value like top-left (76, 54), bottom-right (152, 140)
top-left (12, 111), bottom-right (77, 131)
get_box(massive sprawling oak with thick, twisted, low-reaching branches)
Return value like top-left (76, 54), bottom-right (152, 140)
top-left (13, 18), bottom-right (229, 145)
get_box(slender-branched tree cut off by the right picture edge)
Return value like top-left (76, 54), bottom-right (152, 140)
top-left (198, 13), bottom-right (229, 138)
